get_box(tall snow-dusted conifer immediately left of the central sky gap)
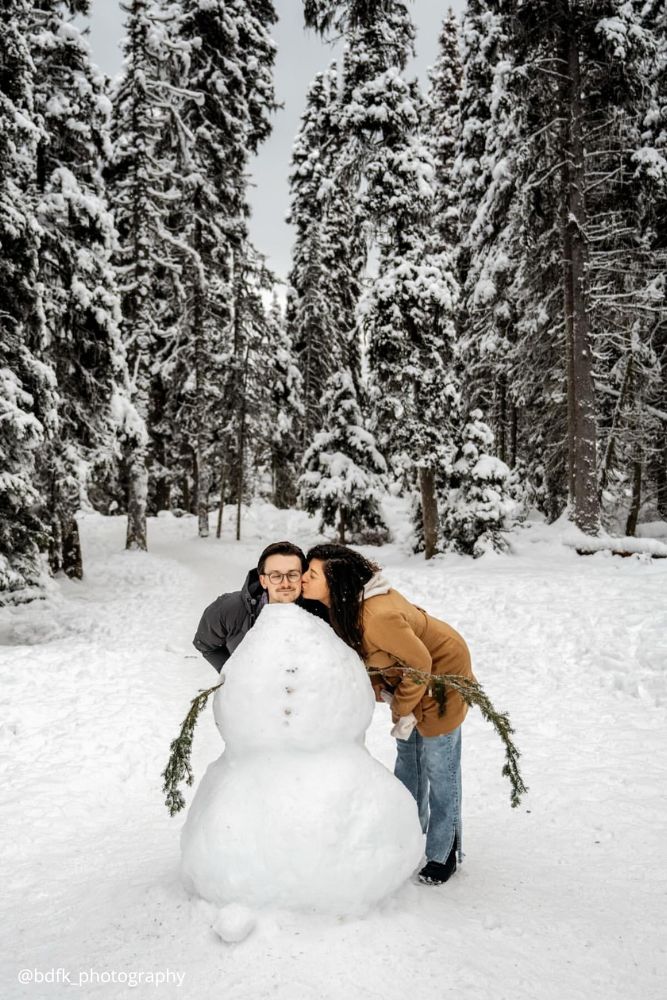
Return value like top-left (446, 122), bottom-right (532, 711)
top-left (153, 0), bottom-right (275, 535)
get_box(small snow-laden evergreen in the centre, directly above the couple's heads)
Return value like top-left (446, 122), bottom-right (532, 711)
top-left (299, 371), bottom-right (388, 545)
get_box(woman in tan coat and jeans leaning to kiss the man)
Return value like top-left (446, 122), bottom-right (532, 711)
top-left (303, 545), bottom-right (474, 885)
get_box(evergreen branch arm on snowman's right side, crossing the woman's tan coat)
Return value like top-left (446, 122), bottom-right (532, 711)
top-left (367, 663), bottom-right (528, 808)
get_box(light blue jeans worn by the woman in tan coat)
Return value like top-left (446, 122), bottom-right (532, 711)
top-left (394, 726), bottom-right (463, 863)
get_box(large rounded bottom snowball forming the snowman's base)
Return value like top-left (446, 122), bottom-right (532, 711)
top-left (181, 744), bottom-right (423, 916)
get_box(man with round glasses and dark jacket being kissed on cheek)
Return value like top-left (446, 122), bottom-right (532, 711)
top-left (193, 542), bottom-right (328, 673)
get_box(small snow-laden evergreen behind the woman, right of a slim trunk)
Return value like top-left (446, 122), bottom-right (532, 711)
top-left (443, 410), bottom-right (516, 556)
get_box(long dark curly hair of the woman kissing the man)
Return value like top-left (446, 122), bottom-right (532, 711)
top-left (306, 544), bottom-right (380, 656)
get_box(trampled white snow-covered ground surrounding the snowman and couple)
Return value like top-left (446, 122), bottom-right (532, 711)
top-left (0, 505), bottom-right (667, 1000)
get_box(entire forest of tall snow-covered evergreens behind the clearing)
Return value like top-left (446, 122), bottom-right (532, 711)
top-left (0, 0), bottom-right (667, 603)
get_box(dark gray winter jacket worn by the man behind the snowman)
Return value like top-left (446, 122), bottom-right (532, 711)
top-left (192, 569), bottom-right (329, 673)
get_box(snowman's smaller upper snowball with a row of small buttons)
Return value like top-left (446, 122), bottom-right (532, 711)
top-left (214, 604), bottom-right (374, 752)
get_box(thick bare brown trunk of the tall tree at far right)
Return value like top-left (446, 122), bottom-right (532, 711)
top-left (562, 18), bottom-right (600, 535)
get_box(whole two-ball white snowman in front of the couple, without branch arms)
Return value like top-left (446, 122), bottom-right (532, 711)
top-left (181, 604), bottom-right (423, 915)
